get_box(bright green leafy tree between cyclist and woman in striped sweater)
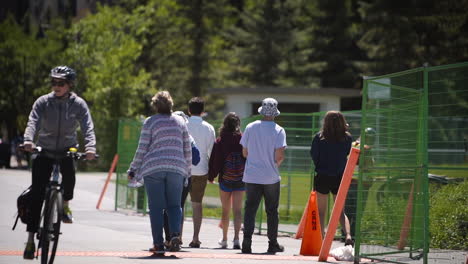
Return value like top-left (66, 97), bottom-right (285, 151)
top-left (65, 6), bottom-right (151, 161)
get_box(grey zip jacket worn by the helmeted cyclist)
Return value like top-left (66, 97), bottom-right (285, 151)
top-left (24, 92), bottom-right (96, 153)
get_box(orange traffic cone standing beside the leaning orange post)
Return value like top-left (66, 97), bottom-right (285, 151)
top-left (300, 191), bottom-right (322, 256)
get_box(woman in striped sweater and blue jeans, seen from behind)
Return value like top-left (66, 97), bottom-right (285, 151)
top-left (128, 91), bottom-right (192, 254)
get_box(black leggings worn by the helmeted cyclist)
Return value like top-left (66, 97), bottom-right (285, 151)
top-left (26, 155), bottom-right (75, 232)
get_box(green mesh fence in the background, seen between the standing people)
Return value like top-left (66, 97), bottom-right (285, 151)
top-left (116, 111), bottom-right (361, 236)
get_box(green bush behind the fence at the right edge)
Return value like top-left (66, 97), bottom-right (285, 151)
top-left (429, 180), bottom-right (468, 250)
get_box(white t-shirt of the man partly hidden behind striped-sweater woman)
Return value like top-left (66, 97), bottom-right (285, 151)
top-left (187, 116), bottom-right (216, 176)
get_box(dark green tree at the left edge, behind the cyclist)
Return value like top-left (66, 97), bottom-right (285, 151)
top-left (0, 16), bottom-right (63, 140)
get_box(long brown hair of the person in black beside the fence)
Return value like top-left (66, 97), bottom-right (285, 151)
top-left (320, 111), bottom-right (351, 142)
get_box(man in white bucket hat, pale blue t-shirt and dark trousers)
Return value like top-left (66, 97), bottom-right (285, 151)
top-left (240, 98), bottom-right (287, 253)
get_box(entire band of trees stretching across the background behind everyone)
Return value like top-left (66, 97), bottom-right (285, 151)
top-left (0, 0), bottom-right (468, 167)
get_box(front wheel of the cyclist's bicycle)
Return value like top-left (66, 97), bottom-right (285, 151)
top-left (40, 189), bottom-right (63, 264)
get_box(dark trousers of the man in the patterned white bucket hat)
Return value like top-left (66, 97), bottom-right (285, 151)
top-left (244, 182), bottom-right (280, 242)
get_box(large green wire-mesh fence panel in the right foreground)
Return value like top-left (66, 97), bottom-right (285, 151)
top-left (356, 63), bottom-right (468, 263)
